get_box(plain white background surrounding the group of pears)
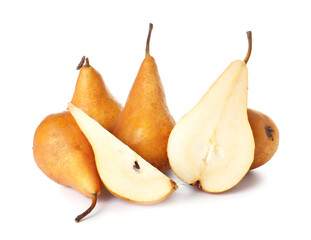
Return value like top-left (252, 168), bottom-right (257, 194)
top-left (0, 0), bottom-right (311, 239)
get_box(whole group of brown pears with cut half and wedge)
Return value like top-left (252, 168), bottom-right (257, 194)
top-left (33, 24), bottom-right (279, 222)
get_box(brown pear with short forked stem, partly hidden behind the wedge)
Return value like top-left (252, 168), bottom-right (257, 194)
top-left (71, 57), bottom-right (122, 131)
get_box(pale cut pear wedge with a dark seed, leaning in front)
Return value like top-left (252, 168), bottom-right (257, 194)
top-left (68, 103), bottom-right (177, 203)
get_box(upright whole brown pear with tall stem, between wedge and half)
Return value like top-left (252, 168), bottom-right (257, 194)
top-left (111, 23), bottom-right (175, 172)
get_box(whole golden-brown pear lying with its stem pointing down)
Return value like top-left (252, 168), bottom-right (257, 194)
top-left (33, 111), bottom-right (102, 222)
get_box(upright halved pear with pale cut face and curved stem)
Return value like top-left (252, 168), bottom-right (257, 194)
top-left (168, 32), bottom-right (255, 193)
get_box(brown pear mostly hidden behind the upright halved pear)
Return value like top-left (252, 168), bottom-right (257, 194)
top-left (247, 108), bottom-right (279, 169)
